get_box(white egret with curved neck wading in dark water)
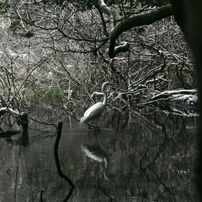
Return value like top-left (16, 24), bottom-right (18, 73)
top-left (80, 82), bottom-right (111, 130)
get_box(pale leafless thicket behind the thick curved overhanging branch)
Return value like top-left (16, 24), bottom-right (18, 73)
top-left (0, 1), bottom-right (195, 112)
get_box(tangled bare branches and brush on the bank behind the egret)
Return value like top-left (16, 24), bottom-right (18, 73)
top-left (0, 0), bottom-right (196, 111)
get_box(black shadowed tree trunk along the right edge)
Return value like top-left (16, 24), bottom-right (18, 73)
top-left (172, 0), bottom-right (202, 199)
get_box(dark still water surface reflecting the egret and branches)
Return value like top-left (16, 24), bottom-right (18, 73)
top-left (0, 109), bottom-right (197, 202)
